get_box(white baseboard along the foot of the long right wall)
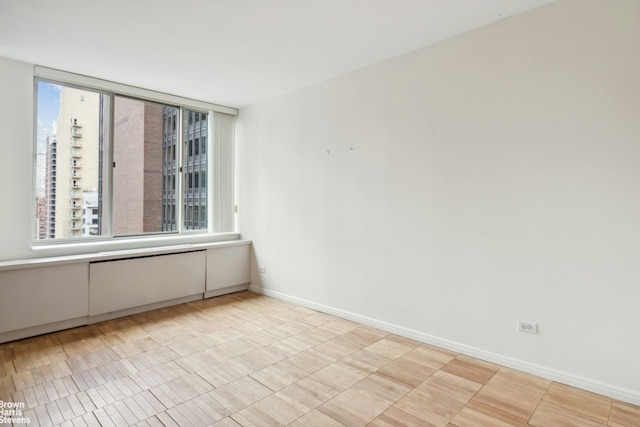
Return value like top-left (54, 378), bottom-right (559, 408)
top-left (249, 285), bottom-right (640, 405)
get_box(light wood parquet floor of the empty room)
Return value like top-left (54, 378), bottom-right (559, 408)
top-left (0, 292), bottom-right (640, 427)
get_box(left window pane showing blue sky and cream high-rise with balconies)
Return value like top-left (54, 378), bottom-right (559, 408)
top-left (35, 80), bottom-right (110, 239)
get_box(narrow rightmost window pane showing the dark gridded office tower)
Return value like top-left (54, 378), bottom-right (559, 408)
top-left (182, 110), bottom-right (209, 230)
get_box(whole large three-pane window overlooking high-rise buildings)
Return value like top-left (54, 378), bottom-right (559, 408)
top-left (34, 68), bottom-right (234, 242)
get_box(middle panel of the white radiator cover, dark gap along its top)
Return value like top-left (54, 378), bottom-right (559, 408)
top-left (89, 250), bottom-right (207, 316)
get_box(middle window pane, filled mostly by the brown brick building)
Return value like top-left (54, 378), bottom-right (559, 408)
top-left (113, 96), bottom-right (179, 235)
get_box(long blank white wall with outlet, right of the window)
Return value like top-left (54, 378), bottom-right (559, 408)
top-left (239, 0), bottom-right (640, 404)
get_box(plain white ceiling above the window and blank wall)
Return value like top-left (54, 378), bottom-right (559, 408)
top-left (0, 0), bottom-right (551, 107)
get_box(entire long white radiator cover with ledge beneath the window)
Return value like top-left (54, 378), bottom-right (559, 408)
top-left (0, 241), bottom-right (251, 343)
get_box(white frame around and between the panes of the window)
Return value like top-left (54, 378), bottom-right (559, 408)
top-left (32, 66), bottom-right (239, 250)
